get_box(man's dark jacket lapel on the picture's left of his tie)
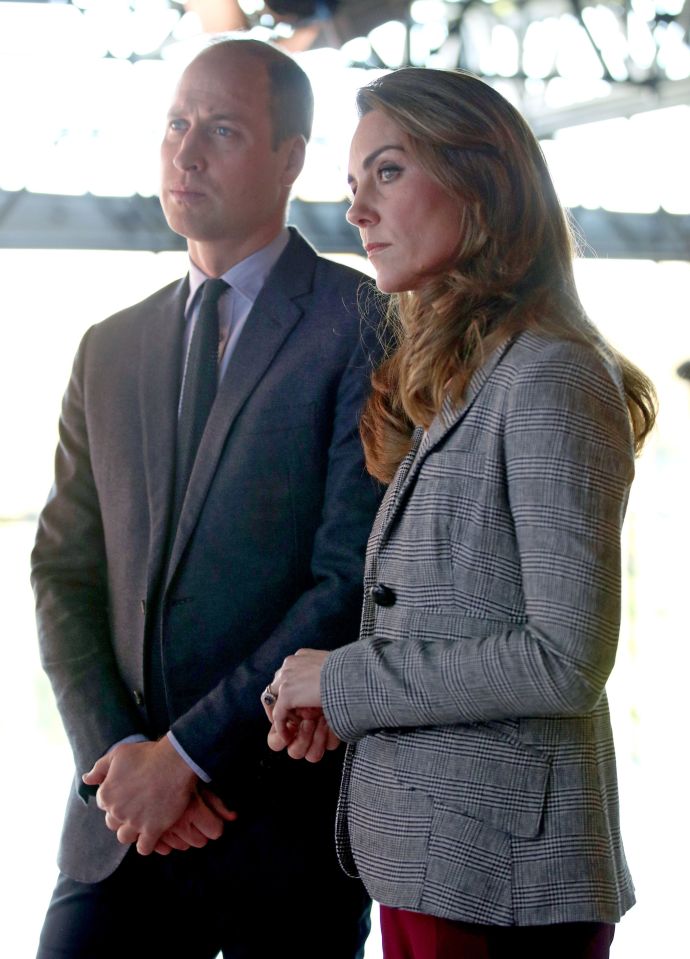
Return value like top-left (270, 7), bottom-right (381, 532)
top-left (139, 278), bottom-right (189, 593)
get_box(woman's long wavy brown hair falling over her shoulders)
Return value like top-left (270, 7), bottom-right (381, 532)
top-left (357, 68), bottom-right (656, 482)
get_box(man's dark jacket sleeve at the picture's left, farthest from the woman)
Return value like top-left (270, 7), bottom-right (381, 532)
top-left (31, 331), bottom-right (141, 795)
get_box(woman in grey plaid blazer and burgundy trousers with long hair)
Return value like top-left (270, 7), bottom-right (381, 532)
top-left (266, 69), bottom-right (655, 959)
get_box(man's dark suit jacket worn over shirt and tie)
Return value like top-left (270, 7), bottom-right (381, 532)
top-left (32, 230), bottom-right (378, 882)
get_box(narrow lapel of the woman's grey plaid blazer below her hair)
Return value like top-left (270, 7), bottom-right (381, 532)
top-left (378, 340), bottom-right (512, 547)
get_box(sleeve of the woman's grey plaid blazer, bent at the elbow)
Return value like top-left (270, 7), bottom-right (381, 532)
top-left (322, 342), bottom-right (633, 742)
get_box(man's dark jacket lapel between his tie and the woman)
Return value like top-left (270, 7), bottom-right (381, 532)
top-left (168, 232), bottom-right (316, 579)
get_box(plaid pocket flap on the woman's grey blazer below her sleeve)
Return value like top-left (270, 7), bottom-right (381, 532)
top-left (396, 723), bottom-right (551, 838)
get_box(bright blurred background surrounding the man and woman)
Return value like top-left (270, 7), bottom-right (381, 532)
top-left (0, 0), bottom-right (690, 959)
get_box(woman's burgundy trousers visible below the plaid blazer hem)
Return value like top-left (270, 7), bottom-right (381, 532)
top-left (380, 906), bottom-right (615, 959)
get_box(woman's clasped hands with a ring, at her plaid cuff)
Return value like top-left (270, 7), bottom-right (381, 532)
top-left (261, 649), bottom-right (340, 763)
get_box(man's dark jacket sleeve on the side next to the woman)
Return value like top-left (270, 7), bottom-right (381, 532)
top-left (166, 294), bottom-right (382, 780)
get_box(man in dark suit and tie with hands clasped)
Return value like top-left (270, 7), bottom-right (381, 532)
top-left (32, 40), bottom-right (378, 959)
